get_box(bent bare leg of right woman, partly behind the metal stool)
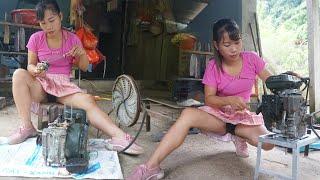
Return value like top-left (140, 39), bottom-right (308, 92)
top-left (235, 124), bottom-right (274, 150)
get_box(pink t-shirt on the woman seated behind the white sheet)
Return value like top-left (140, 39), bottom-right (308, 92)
top-left (27, 30), bottom-right (82, 75)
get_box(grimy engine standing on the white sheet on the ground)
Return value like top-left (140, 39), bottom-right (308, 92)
top-left (39, 108), bottom-right (89, 173)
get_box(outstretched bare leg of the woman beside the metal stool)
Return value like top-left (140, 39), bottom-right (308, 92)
top-left (146, 108), bottom-right (226, 168)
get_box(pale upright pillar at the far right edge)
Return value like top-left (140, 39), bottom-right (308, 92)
top-left (307, 0), bottom-right (320, 112)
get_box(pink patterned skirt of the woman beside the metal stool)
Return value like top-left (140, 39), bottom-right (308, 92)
top-left (198, 106), bottom-right (264, 141)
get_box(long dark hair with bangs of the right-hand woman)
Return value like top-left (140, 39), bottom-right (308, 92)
top-left (212, 19), bottom-right (241, 71)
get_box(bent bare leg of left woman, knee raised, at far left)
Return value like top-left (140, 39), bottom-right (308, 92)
top-left (12, 69), bottom-right (46, 127)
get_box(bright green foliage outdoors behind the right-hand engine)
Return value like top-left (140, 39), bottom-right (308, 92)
top-left (257, 0), bottom-right (308, 76)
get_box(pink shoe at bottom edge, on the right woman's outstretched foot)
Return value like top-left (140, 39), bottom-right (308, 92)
top-left (127, 164), bottom-right (164, 180)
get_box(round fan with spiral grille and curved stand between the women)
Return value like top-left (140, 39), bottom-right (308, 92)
top-left (97, 74), bottom-right (147, 153)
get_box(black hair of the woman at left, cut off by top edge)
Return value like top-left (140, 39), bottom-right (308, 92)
top-left (36, 0), bottom-right (60, 21)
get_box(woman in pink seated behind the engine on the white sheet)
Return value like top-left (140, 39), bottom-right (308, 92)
top-left (8, 0), bottom-right (143, 154)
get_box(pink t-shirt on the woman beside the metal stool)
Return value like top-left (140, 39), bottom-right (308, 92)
top-left (202, 51), bottom-right (266, 102)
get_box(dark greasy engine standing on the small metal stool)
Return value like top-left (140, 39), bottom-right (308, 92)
top-left (257, 74), bottom-right (310, 139)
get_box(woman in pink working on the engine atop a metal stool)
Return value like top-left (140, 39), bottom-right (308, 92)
top-left (128, 19), bottom-right (273, 180)
